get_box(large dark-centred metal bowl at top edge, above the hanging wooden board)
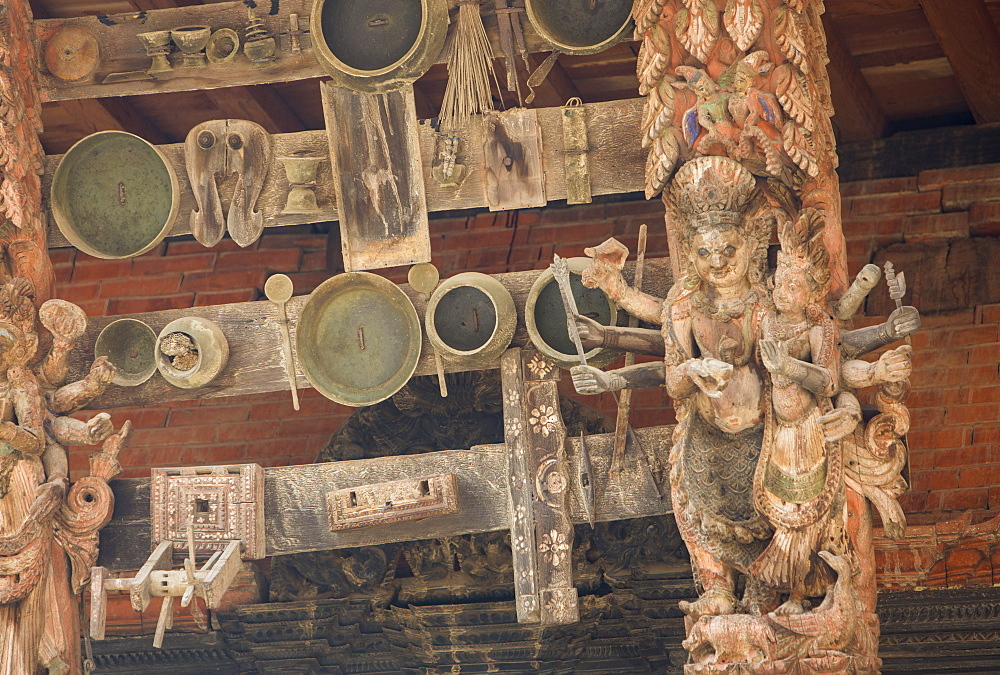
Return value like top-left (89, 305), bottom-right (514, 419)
top-left (309, 0), bottom-right (448, 94)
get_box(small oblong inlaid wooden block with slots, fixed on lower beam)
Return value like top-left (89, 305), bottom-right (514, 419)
top-left (326, 473), bottom-right (458, 532)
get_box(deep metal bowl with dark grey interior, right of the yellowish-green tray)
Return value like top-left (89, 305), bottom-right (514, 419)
top-left (424, 272), bottom-right (517, 367)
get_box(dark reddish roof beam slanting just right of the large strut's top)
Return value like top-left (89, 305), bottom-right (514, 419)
top-left (823, 15), bottom-right (887, 142)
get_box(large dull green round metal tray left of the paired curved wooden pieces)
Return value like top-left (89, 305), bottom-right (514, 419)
top-left (51, 131), bottom-right (180, 258)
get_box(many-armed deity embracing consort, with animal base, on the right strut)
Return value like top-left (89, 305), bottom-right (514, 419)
top-left (573, 156), bottom-right (919, 673)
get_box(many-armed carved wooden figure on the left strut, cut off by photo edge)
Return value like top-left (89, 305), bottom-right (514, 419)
top-left (0, 278), bottom-right (130, 675)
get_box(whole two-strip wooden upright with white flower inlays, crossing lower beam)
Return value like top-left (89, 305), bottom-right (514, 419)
top-left (500, 349), bottom-right (579, 624)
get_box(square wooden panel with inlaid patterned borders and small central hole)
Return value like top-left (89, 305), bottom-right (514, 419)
top-left (150, 464), bottom-right (265, 560)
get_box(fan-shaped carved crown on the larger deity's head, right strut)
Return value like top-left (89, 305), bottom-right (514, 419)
top-left (670, 156), bottom-right (756, 235)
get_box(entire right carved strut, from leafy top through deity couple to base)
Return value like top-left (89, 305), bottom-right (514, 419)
top-left (572, 0), bottom-right (919, 674)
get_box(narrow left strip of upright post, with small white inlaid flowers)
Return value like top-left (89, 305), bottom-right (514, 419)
top-left (500, 349), bottom-right (541, 623)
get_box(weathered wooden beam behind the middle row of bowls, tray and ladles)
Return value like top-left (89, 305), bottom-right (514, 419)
top-left (71, 258), bottom-right (671, 409)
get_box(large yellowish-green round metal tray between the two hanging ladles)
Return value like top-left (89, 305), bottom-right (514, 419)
top-left (295, 272), bottom-right (422, 406)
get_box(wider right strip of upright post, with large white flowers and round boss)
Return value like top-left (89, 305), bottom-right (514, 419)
top-left (521, 350), bottom-right (580, 624)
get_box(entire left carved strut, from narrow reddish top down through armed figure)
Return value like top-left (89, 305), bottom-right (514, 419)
top-left (0, 0), bottom-right (131, 675)
